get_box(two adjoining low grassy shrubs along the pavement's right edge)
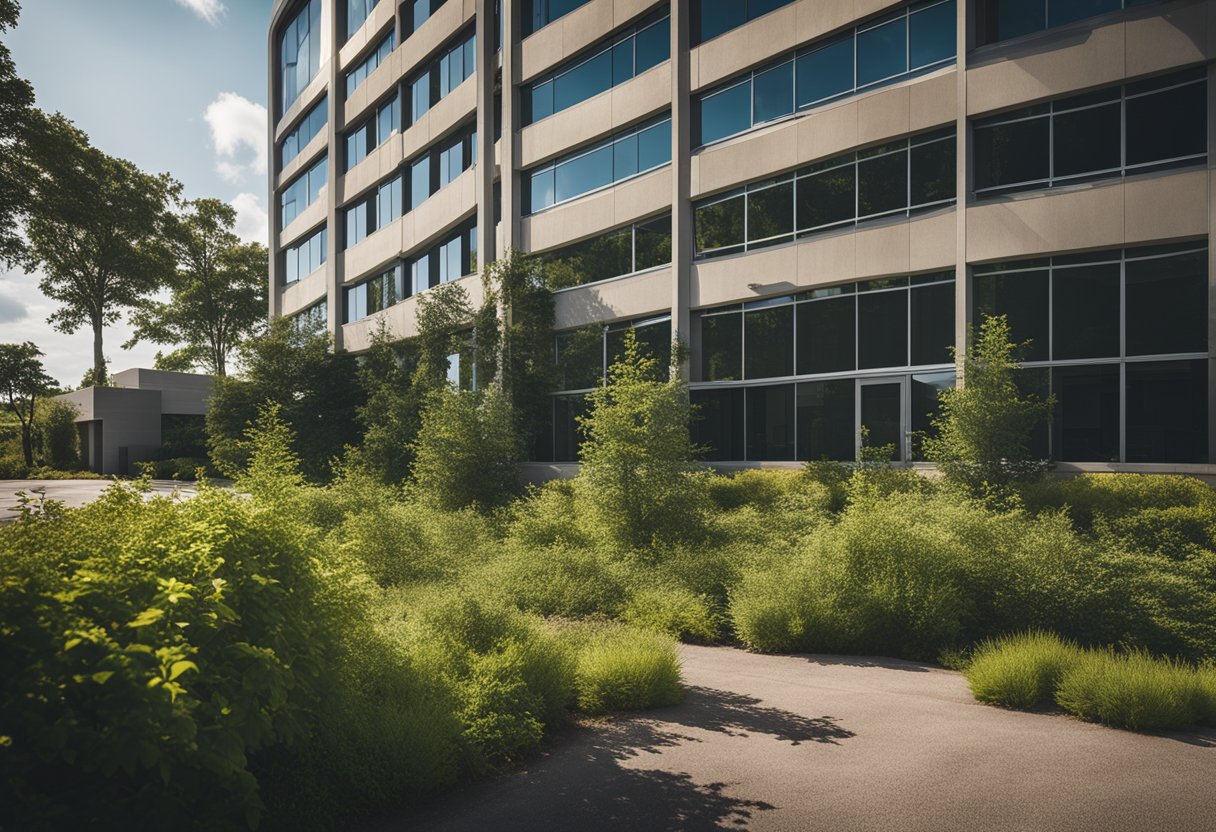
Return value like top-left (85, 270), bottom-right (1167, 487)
top-left (966, 633), bottom-right (1216, 730)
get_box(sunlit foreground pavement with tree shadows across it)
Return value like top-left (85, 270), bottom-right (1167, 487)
top-left (379, 646), bottom-right (1216, 832)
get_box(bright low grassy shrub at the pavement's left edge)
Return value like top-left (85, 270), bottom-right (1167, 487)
top-left (561, 625), bottom-right (683, 714)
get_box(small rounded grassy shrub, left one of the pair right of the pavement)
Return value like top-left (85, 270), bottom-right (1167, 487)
top-left (963, 631), bottom-right (1081, 708)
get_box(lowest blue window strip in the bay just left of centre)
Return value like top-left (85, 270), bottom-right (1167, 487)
top-left (524, 117), bottom-right (671, 214)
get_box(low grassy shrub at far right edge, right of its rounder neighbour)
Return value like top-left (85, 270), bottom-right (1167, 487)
top-left (1055, 651), bottom-right (1200, 731)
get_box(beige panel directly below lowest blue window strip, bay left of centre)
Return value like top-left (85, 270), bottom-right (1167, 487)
top-left (520, 167), bottom-right (671, 252)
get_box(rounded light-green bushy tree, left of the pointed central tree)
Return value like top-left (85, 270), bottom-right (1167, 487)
top-left (413, 387), bottom-right (519, 511)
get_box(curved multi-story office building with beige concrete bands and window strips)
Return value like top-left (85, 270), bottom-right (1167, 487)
top-left (270, 0), bottom-right (1216, 471)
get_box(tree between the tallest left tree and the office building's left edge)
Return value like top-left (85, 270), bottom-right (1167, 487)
top-left (123, 199), bottom-right (270, 376)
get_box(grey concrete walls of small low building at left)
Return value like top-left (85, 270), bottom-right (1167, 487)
top-left (56, 369), bottom-right (212, 474)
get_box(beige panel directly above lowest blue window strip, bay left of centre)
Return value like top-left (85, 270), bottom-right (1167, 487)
top-left (519, 61), bottom-right (671, 168)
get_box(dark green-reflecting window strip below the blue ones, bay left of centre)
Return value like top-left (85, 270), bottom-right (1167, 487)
top-left (536, 214), bottom-right (671, 289)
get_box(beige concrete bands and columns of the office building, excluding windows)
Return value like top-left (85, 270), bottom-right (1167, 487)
top-left (269, 0), bottom-right (1216, 473)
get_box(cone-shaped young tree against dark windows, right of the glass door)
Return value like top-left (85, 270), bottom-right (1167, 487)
top-left (924, 315), bottom-right (1054, 495)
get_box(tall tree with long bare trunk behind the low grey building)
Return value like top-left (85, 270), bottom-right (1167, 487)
top-left (23, 111), bottom-right (181, 382)
